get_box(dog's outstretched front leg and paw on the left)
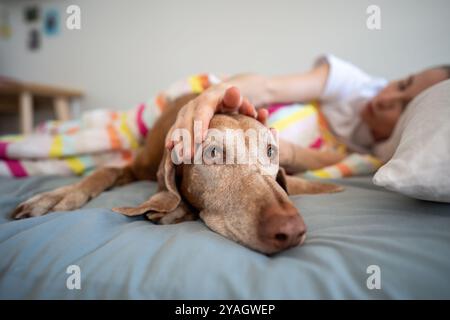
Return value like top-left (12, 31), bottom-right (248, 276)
top-left (12, 167), bottom-right (136, 219)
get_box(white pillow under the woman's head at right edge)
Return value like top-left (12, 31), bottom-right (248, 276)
top-left (373, 80), bottom-right (450, 202)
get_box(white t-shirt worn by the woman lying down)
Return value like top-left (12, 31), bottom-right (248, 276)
top-left (315, 54), bottom-right (387, 152)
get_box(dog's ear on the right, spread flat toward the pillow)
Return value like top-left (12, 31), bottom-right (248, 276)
top-left (276, 167), bottom-right (344, 195)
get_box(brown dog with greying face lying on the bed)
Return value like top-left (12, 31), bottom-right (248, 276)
top-left (13, 95), bottom-right (342, 254)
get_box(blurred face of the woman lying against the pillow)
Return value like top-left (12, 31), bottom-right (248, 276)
top-left (361, 69), bottom-right (448, 141)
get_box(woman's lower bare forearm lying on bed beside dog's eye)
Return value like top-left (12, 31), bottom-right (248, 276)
top-left (279, 139), bottom-right (345, 174)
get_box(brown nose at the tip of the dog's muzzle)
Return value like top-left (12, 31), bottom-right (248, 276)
top-left (259, 203), bottom-right (306, 251)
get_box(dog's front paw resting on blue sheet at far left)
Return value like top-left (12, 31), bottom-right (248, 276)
top-left (11, 186), bottom-right (89, 219)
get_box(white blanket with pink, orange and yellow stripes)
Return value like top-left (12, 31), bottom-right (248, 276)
top-left (0, 74), bottom-right (381, 178)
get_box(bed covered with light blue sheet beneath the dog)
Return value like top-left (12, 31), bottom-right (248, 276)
top-left (0, 176), bottom-right (450, 299)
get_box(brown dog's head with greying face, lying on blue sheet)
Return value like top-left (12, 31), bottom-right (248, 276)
top-left (114, 115), bottom-right (340, 254)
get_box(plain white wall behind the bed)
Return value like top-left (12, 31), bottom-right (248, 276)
top-left (0, 0), bottom-right (450, 108)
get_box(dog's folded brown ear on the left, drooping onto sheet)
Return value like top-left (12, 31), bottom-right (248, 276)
top-left (112, 150), bottom-right (194, 224)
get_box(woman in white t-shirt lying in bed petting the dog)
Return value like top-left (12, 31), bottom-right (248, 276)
top-left (166, 55), bottom-right (450, 173)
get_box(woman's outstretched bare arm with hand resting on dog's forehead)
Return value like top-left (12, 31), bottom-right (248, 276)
top-left (166, 64), bottom-right (329, 155)
